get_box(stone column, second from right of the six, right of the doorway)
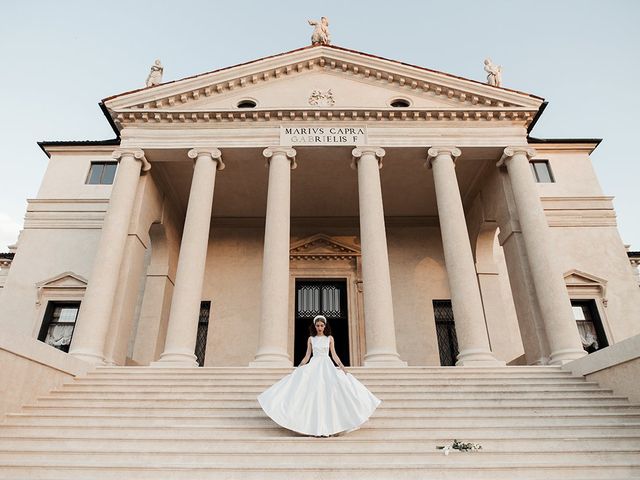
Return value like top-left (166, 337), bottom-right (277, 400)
top-left (427, 147), bottom-right (504, 366)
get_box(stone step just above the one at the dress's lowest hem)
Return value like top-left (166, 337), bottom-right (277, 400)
top-left (5, 413), bottom-right (640, 429)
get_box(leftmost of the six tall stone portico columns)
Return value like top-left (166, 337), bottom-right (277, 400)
top-left (69, 148), bottom-right (151, 364)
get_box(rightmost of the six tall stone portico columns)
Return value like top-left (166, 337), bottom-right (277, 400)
top-left (498, 146), bottom-right (586, 365)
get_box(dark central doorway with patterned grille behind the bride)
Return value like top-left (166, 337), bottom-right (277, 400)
top-left (293, 279), bottom-right (350, 366)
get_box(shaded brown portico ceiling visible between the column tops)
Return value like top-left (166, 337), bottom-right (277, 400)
top-left (146, 147), bottom-right (500, 218)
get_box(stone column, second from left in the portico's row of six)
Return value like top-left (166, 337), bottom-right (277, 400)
top-left (153, 148), bottom-right (224, 367)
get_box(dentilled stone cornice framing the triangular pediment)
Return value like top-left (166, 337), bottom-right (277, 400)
top-left (104, 46), bottom-right (543, 128)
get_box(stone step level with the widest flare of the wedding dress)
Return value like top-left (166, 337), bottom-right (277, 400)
top-left (22, 400), bottom-right (640, 418)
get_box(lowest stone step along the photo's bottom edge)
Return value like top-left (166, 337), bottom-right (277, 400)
top-left (0, 464), bottom-right (640, 480)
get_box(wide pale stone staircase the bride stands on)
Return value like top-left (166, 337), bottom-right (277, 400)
top-left (0, 367), bottom-right (640, 480)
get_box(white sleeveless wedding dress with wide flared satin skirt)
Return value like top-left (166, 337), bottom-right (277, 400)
top-left (258, 336), bottom-right (380, 436)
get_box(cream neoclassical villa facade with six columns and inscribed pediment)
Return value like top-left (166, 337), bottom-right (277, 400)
top-left (0, 45), bottom-right (640, 367)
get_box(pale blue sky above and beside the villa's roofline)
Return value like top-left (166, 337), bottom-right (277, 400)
top-left (0, 0), bottom-right (640, 252)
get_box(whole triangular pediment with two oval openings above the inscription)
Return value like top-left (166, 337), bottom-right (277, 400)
top-left (104, 46), bottom-right (543, 124)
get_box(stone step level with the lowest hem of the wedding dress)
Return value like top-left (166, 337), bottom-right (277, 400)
top-left (0, 423), bottom-right (640, 442)
